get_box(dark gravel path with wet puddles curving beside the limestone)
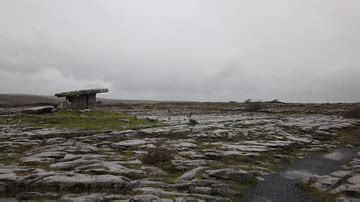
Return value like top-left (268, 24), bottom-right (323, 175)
top-left (245, 148), bottom-right (359, 202)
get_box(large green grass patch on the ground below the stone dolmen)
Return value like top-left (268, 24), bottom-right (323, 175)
top-left (0, 111), bottom-right (160, 131)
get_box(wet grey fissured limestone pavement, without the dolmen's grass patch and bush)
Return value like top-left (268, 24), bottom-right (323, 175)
top-left (0, 106), bottom-right (360, 201)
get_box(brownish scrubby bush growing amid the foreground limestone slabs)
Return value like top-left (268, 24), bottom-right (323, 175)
top-left (141, 142), bottom-right (176, 165)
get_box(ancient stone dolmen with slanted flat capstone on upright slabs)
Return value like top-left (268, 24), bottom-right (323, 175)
top-left (55, 88), bottom-right (109, 110)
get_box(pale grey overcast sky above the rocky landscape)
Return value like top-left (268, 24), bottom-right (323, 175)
top-left (0, 0), bottom-right (360, 102)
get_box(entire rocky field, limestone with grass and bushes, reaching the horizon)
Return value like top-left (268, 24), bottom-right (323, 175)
top-left (0, 103), bottom-right (360, 201)
